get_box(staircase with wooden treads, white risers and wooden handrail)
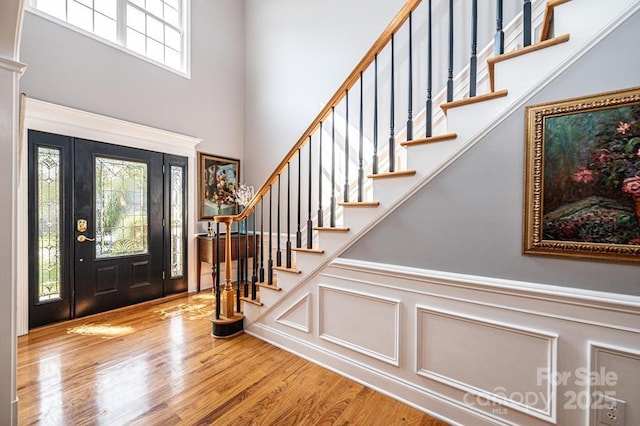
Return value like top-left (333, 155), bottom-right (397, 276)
top-left (217, 0), bottom-right (634, 324)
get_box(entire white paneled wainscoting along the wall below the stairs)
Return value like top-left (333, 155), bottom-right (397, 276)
top-left (246, 259), bottom-right (640, 426)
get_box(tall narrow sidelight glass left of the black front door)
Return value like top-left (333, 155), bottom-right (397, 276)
top-left (38, 147), bottom-right (62, 302)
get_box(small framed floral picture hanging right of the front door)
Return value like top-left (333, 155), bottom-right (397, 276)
top-left (198, 152), bottom-right (240, 220)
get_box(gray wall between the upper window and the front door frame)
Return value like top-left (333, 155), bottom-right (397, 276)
top-left (20, 0), bottom-right (244, 166)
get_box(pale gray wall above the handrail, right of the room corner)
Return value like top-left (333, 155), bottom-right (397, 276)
top-left (244, 0), bottom-right (405, 189)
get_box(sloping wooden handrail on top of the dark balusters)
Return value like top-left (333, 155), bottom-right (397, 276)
top-left (215, 0), bottom-right (422, 223)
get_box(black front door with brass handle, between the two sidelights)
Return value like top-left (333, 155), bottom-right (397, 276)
top-left (73, 140), bottom-right (163, 317)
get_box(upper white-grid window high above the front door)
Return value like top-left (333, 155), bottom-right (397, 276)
top-left (30, 0), bottom-right (187, 73)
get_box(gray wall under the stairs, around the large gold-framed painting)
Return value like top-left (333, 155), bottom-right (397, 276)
top-left (343, 9), bottom-right (640, 295)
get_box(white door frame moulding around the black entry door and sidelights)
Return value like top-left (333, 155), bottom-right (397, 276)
top-left (16, 95), bottom-right (202, 336)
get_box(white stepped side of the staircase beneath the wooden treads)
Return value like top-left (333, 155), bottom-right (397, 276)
top-left (244, 0), bottom-right (640, 334)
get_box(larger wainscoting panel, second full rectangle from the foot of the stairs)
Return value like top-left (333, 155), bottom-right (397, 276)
top-left (416, 306), bottom-right (557, 419)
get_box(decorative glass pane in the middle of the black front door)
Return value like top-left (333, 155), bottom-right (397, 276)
top-left (95, 157), bottom-right (148, 258)
